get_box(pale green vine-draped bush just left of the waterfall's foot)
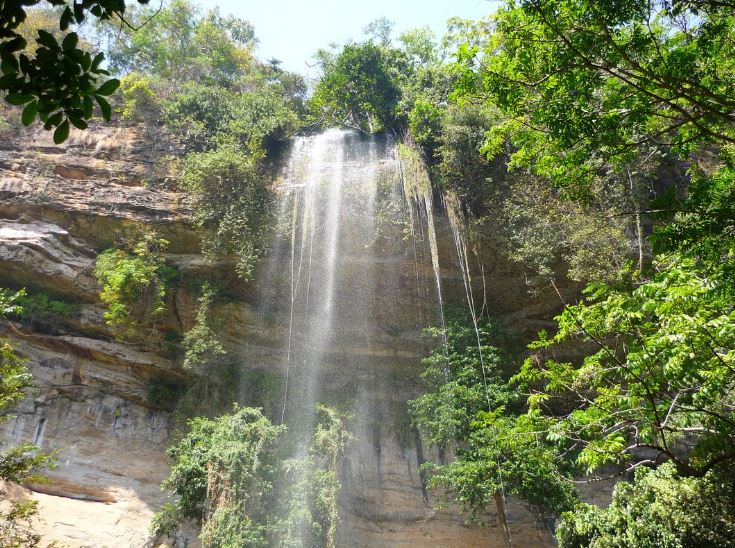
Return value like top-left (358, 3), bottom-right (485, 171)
top-left (152, 407), bottom-right (285, 546)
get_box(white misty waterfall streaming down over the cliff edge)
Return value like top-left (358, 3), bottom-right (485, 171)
top-left (259, 129), bottom-right (398, 453)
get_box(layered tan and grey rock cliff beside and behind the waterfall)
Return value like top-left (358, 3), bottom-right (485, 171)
top-left (0, 125), bottom-right (576, 547)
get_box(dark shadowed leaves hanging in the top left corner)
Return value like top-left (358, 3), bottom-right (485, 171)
top-left (0, 0), bottom-right (148, 143)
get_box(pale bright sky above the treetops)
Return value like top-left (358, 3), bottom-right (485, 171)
top-left (195, 0), bottom-right (498, 76)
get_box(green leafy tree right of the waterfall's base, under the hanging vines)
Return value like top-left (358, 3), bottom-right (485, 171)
top-left (410, 314), bottom-right (577, 518)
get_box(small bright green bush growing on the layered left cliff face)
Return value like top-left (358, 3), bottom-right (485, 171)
top-left (94, 232), bottom-right (168, 337)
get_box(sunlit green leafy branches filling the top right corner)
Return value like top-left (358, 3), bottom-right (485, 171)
top-left (457, 0), bottom-right (735, 194)
